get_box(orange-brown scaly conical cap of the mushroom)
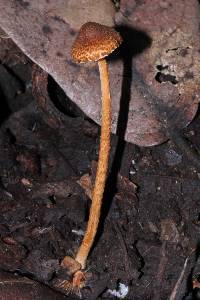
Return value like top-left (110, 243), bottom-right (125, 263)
top-left (71, 22), bottom-right (122, 63)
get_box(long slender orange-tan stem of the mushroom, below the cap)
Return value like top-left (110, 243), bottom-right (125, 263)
top-left (75, 59), bottom-right (111, 269)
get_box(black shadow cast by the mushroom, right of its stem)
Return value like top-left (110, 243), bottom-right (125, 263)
top-left (97, 26), bottom-right (152, 239)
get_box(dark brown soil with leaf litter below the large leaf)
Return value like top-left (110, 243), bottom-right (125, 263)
top-left (0, 40), bottom-right (200, 300)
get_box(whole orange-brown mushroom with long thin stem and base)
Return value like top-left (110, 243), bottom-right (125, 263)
top-left (59, 22), bottom-right (122, 290)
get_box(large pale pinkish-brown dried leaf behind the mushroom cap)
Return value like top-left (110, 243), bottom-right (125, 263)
top-left (0, 0), bottom-right (200, 146)
